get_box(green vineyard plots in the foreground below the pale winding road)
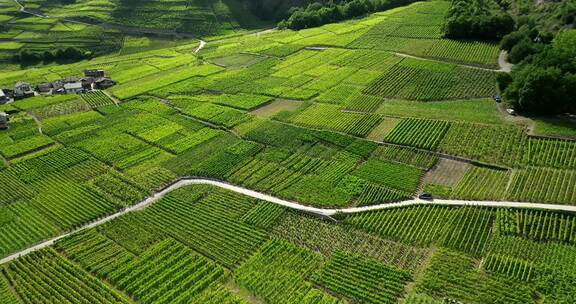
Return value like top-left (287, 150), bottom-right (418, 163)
top-left (0, 180), bottom-right (576, 304)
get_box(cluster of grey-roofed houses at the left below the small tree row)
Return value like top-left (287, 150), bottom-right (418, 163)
top-left (0, 70), bottom-right (116, 104)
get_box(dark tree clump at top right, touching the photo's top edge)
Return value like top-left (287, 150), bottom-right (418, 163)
top-left (444, 0), bottom-right (514, 40)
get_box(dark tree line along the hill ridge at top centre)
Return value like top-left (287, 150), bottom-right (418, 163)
top-left (278, 0), bottom-right (415, 30)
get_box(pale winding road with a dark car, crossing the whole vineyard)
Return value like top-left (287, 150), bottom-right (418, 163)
top-left (0, 177), bottom-right (576, 265)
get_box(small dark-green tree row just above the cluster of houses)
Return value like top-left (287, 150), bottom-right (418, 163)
top-left (14, 46), bottom-right (92, 64)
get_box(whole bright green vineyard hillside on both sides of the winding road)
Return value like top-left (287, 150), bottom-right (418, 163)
top-left (0, 0), bottom-right (576, 304)
